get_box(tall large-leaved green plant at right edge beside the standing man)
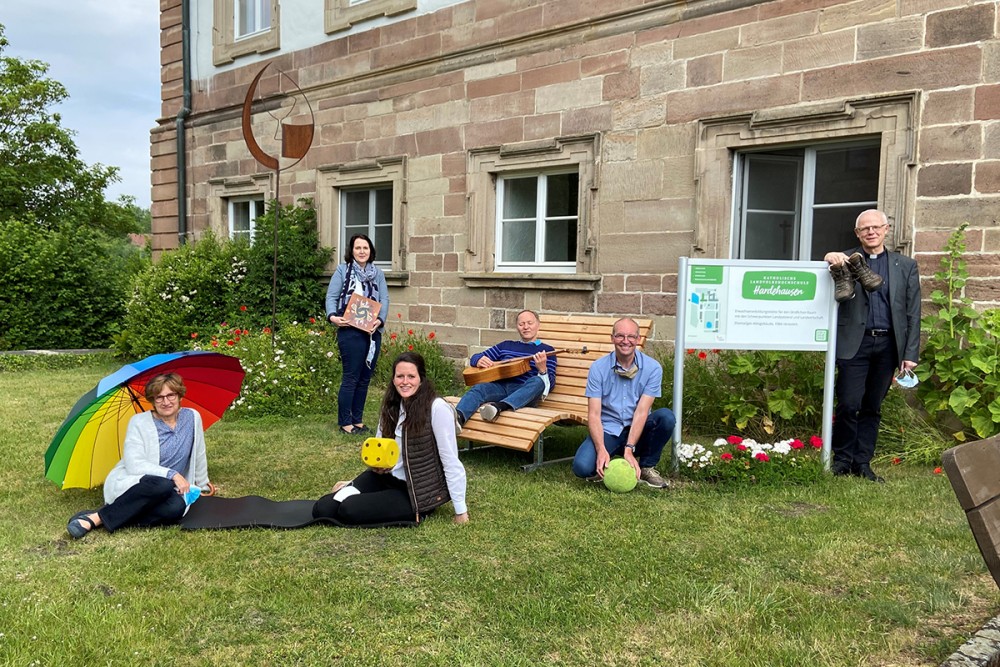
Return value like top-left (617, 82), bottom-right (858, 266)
top-left (915, 223), bottom-right (1000, 441)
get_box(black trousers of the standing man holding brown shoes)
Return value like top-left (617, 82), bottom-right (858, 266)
top-left (830, 334), bottom-right (899, 472)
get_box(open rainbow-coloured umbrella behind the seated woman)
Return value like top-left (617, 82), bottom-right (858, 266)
top-left (45, 351), bottom-right (246, 489)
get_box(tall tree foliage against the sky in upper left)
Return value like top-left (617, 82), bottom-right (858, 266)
top-left (0, 25), bottom-right (130, 235)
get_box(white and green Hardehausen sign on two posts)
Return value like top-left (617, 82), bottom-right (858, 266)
top-left (673, 257), bottom-right (837, 470)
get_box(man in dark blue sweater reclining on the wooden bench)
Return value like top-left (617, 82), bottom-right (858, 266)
top-left (455, 310), bottom-right (556, 425)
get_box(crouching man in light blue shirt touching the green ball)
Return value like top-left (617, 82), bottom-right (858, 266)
top-left (573, 317), bottom-right (676, 489)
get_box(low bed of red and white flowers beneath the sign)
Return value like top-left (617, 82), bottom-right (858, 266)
top-left (677, 435), bottom-right (823, 484)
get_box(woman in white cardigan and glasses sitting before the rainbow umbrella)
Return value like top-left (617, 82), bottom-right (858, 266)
top-left (66, 373), bottom-right (215, 539)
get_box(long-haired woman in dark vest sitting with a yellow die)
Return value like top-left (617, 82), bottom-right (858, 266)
top-left (313, 352), bottom-right (469, 526)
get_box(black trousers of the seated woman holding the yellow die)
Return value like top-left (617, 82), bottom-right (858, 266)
top-left (313, 470), bottom-right (416, 526)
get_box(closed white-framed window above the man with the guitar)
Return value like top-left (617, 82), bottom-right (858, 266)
top-left (496, 170), bottom-right (580, 273)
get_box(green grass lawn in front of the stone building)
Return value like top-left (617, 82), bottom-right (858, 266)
top-left (0, 366), bottom-right (1000, 667)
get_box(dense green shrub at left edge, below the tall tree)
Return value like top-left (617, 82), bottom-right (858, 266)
top-left (0, 220), bottom-right (147, 350)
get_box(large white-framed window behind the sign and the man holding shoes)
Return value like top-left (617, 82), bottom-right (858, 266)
top-left (732, 140), bottom-right (881, 261)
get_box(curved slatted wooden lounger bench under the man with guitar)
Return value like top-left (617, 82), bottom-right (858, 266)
top-left (446, 314), bottom-right (653, 470)
